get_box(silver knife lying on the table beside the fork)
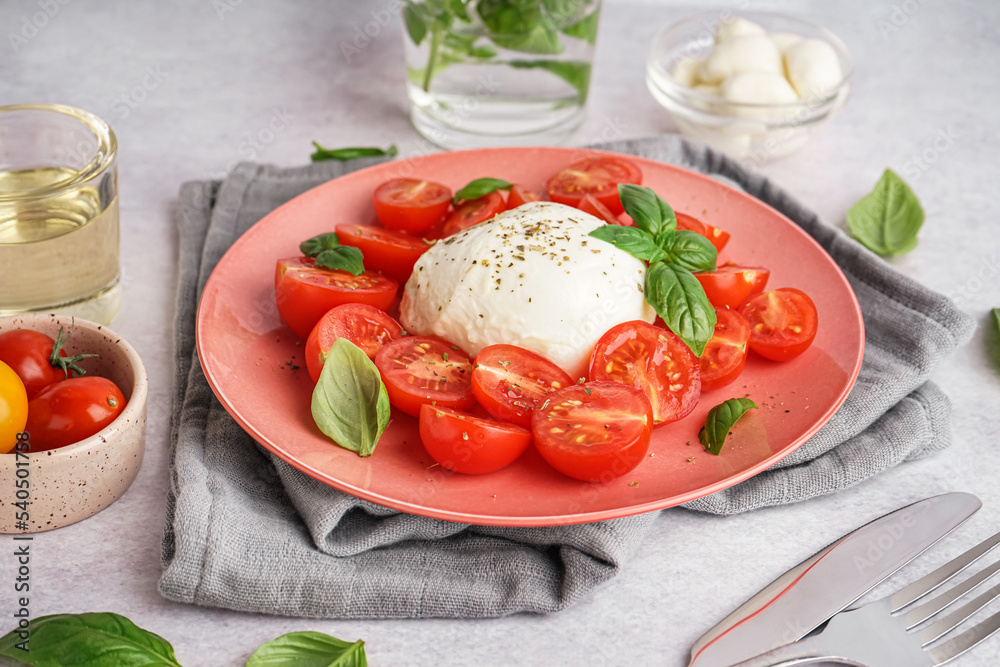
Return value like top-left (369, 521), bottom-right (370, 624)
top-left (688, 493), bottom-right (982, 667)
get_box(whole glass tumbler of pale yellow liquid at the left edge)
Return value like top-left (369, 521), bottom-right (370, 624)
top-left (0, 104), bottom-right (121, 324)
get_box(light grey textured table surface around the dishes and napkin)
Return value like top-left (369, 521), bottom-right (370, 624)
top-left (0, 0), bottom-right (1000, 667)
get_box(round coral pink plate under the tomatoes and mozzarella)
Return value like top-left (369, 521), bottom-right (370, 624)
top-left (197, 148), bottom-right (864, 526)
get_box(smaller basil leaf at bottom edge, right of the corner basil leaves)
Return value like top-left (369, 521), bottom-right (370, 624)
top-left (247, 632), bottom-right (368, 667)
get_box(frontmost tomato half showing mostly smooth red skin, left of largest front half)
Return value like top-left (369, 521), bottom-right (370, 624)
top-left (420, 403), bottom-right (531, 475)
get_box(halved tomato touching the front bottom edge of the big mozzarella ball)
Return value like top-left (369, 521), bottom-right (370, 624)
top-left (472, 345), bottom-right (573, 426)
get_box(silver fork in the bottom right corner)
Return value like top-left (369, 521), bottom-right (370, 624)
top-left (733, 533), bottom-right (1000, 667)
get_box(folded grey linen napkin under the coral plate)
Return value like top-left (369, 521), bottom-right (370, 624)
top-left (160, 136), bottom-right (975, 618)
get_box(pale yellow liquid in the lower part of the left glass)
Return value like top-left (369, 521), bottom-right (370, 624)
top-left (0, 167), bottom-right (121, 323)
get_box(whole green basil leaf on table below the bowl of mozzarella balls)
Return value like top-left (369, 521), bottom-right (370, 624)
top-left (847, 169), bottom-right (924, 255)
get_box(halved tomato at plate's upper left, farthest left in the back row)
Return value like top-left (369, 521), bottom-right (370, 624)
top-left (374, 178), bottom-right (451, 233)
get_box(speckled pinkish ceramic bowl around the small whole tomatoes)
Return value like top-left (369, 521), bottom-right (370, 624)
top-left (0, 314), bottom-right (147, 533)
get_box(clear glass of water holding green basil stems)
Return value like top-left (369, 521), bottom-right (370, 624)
top-left (403, 0), bottom-right (601, 149)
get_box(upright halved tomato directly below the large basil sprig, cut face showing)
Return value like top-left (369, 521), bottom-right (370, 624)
top-left (589, 320), bottom-right (701, 426)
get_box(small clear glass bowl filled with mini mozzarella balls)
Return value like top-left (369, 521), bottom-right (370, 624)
top-left (646, 10), bottom-right (854, 165)
